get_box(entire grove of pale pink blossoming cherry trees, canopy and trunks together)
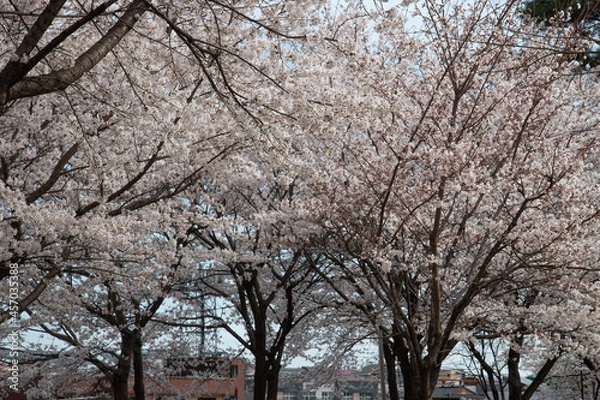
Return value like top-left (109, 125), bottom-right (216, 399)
top-left (0, 0), bottom-right (600, 400)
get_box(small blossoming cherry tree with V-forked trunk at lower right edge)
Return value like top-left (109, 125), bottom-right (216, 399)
top-left (467, 268), bottom-right (598, 399)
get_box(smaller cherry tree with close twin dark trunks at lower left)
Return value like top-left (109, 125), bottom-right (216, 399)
top-left (23, 228), bottom-right (192, 400)
